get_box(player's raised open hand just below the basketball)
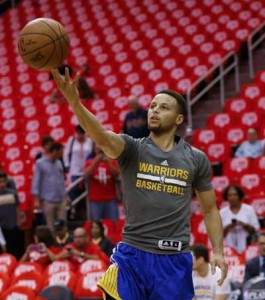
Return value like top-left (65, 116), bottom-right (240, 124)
top-left (51, 68), bottom-right (80, 107)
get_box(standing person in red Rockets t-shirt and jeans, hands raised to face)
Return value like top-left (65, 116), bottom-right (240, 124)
top-left (85, 144), bottom-right (119, 222)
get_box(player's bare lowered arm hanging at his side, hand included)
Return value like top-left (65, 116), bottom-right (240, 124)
top-left (196, 190), bottom-right (227, 285)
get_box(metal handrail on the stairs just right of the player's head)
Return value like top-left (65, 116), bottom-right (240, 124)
top-left (186, 52), bottom-right (240, 128)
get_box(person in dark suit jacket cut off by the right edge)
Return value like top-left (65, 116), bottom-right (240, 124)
top-left (244, 232), bottom-right (265, 282)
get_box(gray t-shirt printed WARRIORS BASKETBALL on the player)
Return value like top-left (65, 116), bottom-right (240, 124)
top-left (118, 134), bottom-right (212, 254)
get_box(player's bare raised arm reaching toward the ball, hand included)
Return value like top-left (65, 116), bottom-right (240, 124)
top-left (52, 68), bottom-right (125, 159)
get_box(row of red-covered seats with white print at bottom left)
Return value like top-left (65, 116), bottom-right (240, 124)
top-left (0, 254), bottom-right (107, 299)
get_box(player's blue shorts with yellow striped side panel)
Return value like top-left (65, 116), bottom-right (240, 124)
top-left (99, 243), bottom-right (194, 300)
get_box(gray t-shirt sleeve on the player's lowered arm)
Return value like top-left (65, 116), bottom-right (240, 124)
top-left (193, 151), bottom-right (213, 191)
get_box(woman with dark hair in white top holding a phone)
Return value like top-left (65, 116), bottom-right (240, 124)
top-left (220, 185), bottom-right (260, 254)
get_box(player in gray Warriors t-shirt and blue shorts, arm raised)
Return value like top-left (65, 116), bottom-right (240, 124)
top-left (52, 70), bottom-right (227, 300)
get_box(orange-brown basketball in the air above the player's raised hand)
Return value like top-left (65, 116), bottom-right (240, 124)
top-left (18, 18), bottom-right (70, 70)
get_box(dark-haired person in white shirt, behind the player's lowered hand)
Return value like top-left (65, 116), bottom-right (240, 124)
top-left (191, 244), bottom-right (231, 300)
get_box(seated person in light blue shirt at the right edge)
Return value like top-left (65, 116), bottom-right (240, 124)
top-left (235, 128), bottom-right (264, 158)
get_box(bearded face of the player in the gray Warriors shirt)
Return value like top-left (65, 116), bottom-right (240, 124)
top-left (148, 94), bottom-right (183, 134)
